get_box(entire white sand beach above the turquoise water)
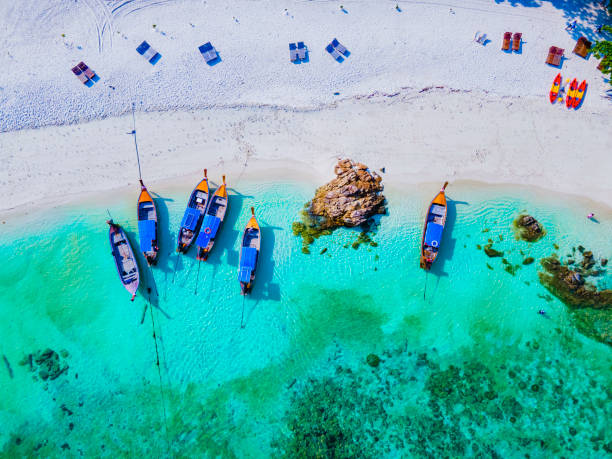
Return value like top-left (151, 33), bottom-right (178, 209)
top-left (0, 0), bottom-right (612, 212)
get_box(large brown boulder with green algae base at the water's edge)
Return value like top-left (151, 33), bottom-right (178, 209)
top-left (292, 159), bottom-right (387, 253)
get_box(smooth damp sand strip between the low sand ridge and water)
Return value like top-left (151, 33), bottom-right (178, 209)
top-left (0, 88), bottom-right (612, 221)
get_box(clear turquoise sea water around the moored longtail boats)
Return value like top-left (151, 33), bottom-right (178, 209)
top-left (0, 183), bottom-right (612, 457)
